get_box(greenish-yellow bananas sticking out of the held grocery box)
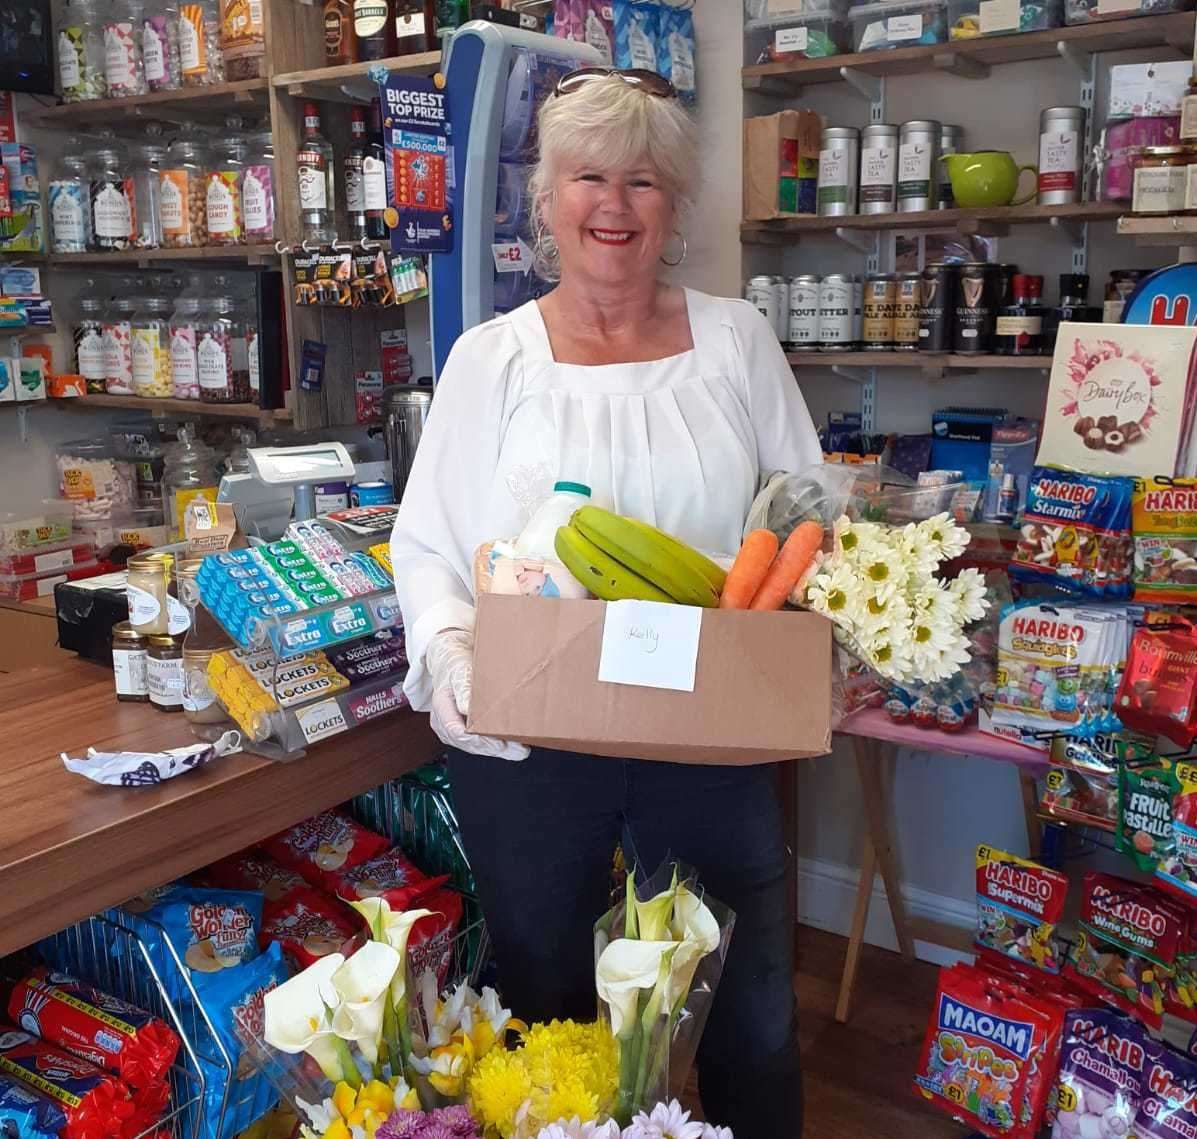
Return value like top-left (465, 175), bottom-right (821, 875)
top-left (554, 506), bottom-right (727, 609)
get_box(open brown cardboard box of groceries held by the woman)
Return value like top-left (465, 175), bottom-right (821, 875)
top-left (469, 593), bottom-right (832, 766)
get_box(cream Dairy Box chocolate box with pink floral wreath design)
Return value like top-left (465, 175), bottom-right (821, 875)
top-left (1035, 322), bottom-right (1197, 475)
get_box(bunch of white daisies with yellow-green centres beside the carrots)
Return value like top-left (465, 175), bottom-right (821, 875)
top-left (790, 513), bottom-right (989, 684)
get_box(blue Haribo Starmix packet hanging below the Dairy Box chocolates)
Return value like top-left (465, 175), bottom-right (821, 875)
top-left (1010, 467), bottom-right (1134, 601)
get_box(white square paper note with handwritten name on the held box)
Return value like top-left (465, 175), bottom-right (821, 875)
top-left (599, 601), bottom-right (703, 692)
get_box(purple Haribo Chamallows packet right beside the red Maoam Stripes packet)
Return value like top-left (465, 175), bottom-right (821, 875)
top-left (1047, 1009), bottom-right (1162, 1139)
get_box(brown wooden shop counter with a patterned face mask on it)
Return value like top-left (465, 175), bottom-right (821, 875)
top-left (0, 654), bottom-right (442, 955)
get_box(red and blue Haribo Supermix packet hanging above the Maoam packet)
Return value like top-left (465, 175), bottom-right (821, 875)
top-left (977, 843), bottom-right (1068, 973)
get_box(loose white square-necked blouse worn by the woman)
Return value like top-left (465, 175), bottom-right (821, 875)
top-left (390, 290), bottom-right (822, 711)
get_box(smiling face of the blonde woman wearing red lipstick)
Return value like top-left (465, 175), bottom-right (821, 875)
top-left (545, 162), bottom-right (676, 285)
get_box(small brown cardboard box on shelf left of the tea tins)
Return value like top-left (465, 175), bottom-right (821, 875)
top-left (743, 111), bottom-right (822, 221)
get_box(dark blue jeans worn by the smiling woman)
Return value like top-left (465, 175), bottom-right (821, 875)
top-left (449, 749), bottom-right (802, 1139)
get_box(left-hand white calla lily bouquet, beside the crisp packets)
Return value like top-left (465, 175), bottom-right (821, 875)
top-left (262, 899), bottom-right (431, 1139)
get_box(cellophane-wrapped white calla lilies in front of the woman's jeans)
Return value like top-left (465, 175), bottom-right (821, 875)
top-left (595, 864), bottom-right (735, 1125)
